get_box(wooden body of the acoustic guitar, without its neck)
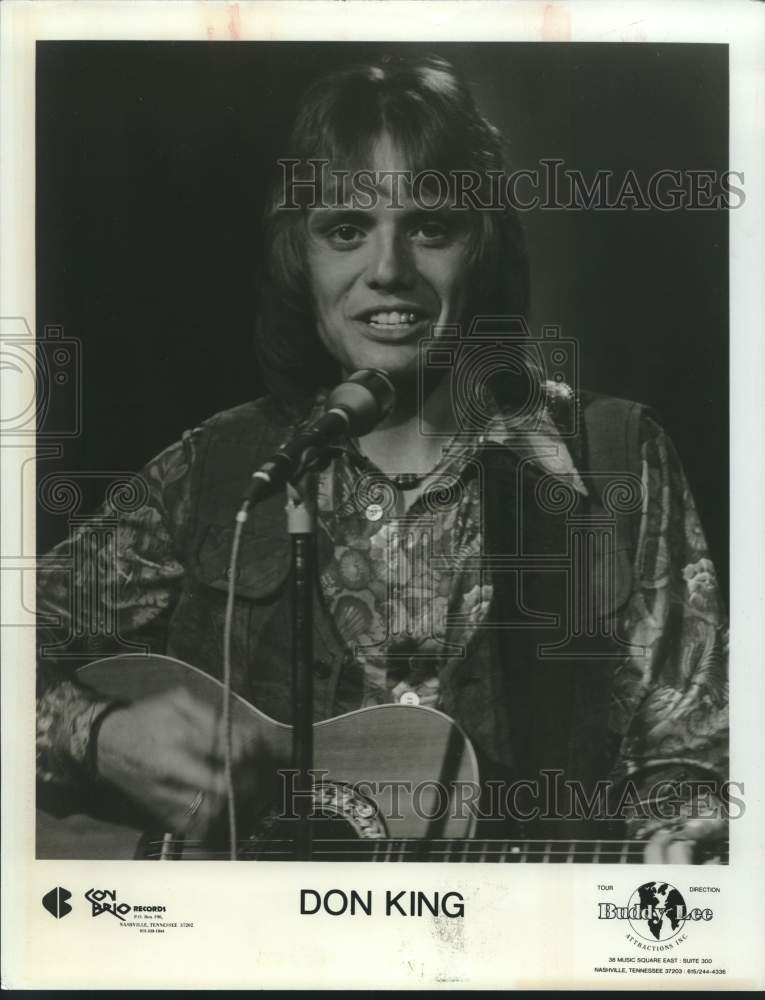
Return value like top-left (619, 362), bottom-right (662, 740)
top-left (37, 654), bottom-right (479, 860)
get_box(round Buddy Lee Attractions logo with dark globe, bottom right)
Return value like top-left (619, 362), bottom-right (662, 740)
top-left (598, 882), bottom-right (714, 951)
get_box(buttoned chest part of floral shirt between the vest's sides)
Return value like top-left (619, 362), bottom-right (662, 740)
top-left (318, 422), bottom-right (501, 708)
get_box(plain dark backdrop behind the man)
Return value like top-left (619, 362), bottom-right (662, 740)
top-left (37, 42), bottom-right (735, 588)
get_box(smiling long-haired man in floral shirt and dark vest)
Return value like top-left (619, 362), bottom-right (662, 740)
top-left (38, 57), bottom-right (727, 861)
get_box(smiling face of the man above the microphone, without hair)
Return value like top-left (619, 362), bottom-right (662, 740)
top-left (307, 140), bottom-right (469, 380)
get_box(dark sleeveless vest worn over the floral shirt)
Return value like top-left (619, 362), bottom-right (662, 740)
top-left (167, 397), bottom-right (640, 832)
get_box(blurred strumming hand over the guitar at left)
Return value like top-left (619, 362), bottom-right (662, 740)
top-left (96, 688), bottom-right (267, 839)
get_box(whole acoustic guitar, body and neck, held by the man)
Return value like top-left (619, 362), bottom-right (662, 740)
top-left (37, 654), bottom-right (726, 864)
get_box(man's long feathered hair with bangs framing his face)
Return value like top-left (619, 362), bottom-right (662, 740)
top-left (256, 55), bottom-right (529, 410)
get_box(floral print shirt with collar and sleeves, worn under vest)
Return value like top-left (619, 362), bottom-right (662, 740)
top-left (37, 386), bottom-right (727, 824)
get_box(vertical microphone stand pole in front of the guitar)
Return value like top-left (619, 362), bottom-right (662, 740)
top-left (286, 472), bottom-right (316, 861)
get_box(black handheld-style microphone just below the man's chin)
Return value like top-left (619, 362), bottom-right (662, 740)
top-left (244, 368), bottom-right (396, 506)
